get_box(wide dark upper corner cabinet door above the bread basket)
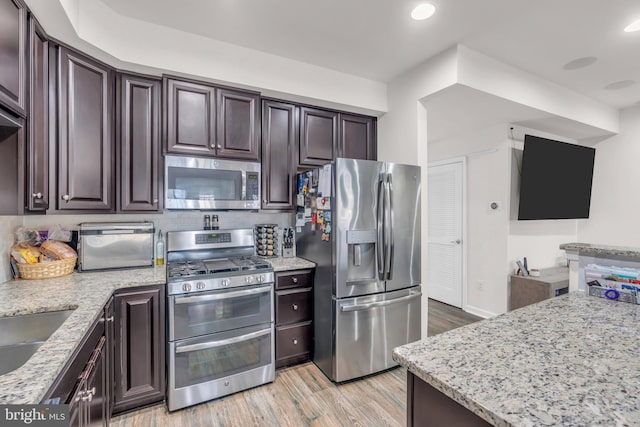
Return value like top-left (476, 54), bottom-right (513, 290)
top-left (58, 48), bottom-right (115, 211)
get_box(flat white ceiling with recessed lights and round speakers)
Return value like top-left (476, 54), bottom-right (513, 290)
top-left (101, 0), bottom-right (640, 108)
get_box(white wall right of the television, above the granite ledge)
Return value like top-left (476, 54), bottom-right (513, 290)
top-left (578, 106), bottom-right (640, 248)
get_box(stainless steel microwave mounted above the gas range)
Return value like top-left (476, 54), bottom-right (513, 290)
top-left (165, 155), bottom-right (261, 210)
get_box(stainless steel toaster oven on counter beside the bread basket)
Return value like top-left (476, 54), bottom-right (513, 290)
top-left (78, 222), bottom-right (154, 271)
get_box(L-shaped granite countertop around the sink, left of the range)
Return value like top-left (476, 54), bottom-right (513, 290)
top-left (0, 266), bottom-right (166, 404)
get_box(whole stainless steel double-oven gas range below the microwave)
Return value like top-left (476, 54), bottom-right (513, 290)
top-left (167, 229), bottom-right (275, 411)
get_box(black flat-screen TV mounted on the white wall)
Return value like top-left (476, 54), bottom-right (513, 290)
top-left (518, 135), bottom-right (596, 220)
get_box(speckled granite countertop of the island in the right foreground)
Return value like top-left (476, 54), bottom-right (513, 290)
top-left (393, 293), bottom-right (640, 426)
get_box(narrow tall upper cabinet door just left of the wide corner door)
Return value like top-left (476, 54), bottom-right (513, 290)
top-left (25, 16), bottom-right (49, 211)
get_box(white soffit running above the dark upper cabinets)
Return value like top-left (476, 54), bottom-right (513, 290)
top-left (22, 0), bottom-right (387, 115)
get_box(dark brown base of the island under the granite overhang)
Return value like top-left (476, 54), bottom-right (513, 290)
top-left (407, 372), bottom-right (491, 427)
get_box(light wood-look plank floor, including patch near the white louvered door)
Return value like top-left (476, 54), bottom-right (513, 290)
top-left (111, 299), bottom-right (480, 427)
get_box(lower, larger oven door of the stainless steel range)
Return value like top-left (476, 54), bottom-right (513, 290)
top-left (167, 323), bottom-right (275, 411)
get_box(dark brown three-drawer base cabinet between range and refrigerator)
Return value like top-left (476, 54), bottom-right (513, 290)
top-left (275, 270), bottom-right (313, 368)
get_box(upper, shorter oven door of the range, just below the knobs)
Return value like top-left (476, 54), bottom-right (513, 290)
top-left (168, 284), bottom-right (273, 341)
